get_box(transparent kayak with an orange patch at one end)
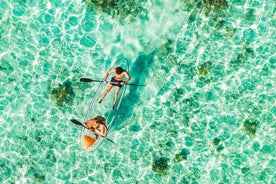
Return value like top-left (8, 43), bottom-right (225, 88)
top-left (80, 59), bottom-right (129, 152)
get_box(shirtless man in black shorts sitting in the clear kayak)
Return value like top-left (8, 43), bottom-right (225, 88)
top-left (99, 67), bottom-right (130, 109)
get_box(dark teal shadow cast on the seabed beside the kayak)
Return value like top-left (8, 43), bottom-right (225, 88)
top-left (113, 52), bottom-right (154, 130)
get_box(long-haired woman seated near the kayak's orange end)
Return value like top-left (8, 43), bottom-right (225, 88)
top-left (84, 116), bottom-right (107, 139)
